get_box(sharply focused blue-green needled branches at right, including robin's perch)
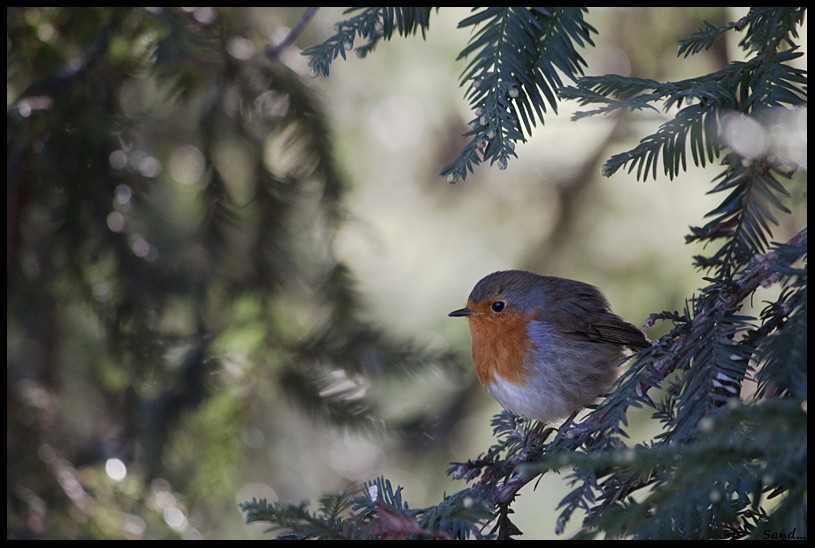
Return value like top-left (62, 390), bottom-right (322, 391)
top-left (243, 8), bottom-right (807, 539)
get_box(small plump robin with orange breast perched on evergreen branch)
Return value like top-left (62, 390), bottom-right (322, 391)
top-left (449, 270), bottom-right (651, 422)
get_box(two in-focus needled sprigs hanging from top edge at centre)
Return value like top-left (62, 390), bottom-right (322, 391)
top-left (303, 7), bottom-right (597, 182)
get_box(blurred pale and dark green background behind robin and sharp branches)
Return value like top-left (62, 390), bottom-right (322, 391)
top-left (6, 8), bottom-right (806, 539)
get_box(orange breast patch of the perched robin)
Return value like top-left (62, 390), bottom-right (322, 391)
top-left (468, 312), bottom-right (530, 386)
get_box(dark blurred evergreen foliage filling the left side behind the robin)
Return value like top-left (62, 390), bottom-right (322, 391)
top-left (7, 8), bottom-right (462, 538)
